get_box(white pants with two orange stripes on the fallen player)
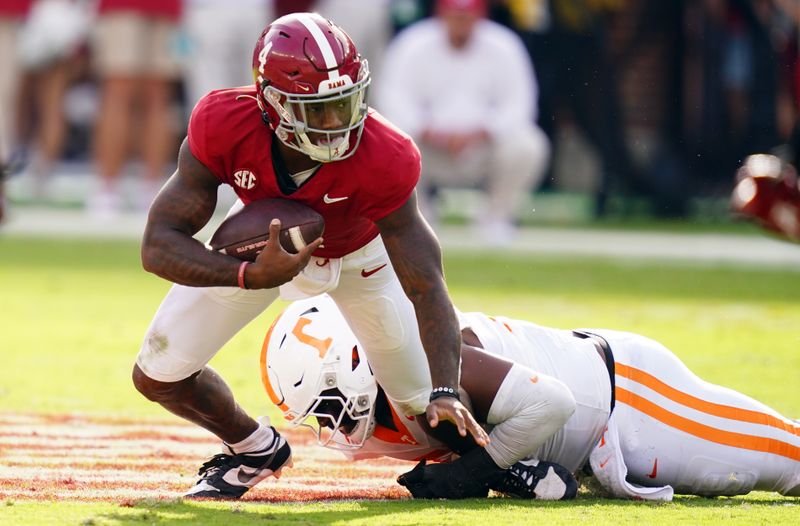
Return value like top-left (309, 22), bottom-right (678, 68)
top-left (592, 329), bottom-right (800, 495)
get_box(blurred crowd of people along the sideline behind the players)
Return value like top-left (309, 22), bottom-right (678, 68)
top-left (0, 0), bottom-right (800, 240)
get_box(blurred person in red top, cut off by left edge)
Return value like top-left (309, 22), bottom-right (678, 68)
top-left (0, 0), bottom-right (32, 221)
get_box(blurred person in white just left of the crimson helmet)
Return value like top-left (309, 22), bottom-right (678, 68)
top-left (183, 0), bottom-right (274, 111)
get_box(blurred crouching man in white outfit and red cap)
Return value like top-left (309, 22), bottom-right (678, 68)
top-left (375, 0), bottom-right (550, 245)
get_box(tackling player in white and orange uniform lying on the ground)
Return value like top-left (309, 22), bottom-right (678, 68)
top-left (261, 296), bottom-right (800, 500)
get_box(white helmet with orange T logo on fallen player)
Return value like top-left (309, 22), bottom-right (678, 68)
top-left (261, 295), bottom-right (378, 449)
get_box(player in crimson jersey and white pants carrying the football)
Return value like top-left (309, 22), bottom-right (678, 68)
top-left (133, 13), bottom-right (488, 498)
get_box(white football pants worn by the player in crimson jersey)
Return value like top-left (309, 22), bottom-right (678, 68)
top-left (136, 236), bottom-right (432, 415)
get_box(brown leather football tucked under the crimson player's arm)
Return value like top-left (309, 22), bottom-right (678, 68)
top-left (208, 199), bottom-right (325, 261)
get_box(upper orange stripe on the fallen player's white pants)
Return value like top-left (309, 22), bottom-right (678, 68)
top-left (615, 362), bottom-right (800, 436)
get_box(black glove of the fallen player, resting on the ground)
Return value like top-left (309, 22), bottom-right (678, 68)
top-left (397, 448), bottom-right (506, 499)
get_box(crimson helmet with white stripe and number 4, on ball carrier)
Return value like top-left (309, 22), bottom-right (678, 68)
top-left (253, 13), bottom-right (370, 162)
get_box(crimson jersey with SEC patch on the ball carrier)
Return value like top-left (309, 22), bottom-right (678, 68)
top-left (188, 87), bottom-right (420, 258)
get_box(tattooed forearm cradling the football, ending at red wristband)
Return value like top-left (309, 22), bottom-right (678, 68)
top-left (142, 228), bottom-right (241, 287)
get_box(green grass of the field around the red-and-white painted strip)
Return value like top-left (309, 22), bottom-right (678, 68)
top-left (0, 238), bottom-right (800, 525)
